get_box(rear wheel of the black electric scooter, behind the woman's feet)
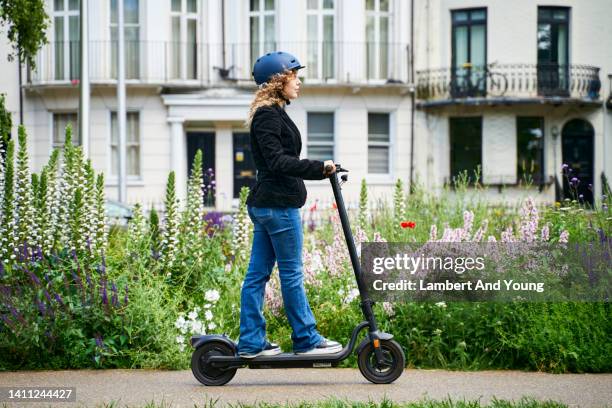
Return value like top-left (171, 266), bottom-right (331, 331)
top-left (191, 341), bottom-right (237, 385)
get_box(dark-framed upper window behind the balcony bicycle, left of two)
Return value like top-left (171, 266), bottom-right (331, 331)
top-left (451, 9), bottom-right (487, 97)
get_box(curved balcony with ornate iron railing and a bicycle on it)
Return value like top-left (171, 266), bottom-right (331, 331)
top-left (416, 63), bottom-right (601, 108)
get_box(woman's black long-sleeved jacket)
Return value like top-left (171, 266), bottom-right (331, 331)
top-left (247, 104), bottom-right (325, 208)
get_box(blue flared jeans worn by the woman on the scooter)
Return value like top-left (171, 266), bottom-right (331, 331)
top-left (238, 206), bottom-right (322, 353)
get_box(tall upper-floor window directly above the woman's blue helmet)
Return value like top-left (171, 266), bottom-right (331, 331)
top-left (249, 0), bottom-right (276, 66)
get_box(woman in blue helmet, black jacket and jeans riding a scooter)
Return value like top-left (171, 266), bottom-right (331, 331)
top-left (238, 52), bottom-right (342, 358)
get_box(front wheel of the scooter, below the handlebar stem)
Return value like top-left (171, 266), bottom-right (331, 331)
top-left (357, 340), bottom-right (406, 384)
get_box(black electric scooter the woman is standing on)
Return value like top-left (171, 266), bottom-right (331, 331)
top-left (191, 164), bottom-right (406, 385)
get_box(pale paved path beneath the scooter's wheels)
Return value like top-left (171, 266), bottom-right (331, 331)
top-left (0, 369), bottom-right (612, 407)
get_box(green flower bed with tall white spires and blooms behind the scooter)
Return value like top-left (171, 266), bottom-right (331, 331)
top-left (0, 128), bottom-right (612, 372)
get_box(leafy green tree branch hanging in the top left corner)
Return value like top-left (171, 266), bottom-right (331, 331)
top-left (0, 0), bottom-right (49, 68)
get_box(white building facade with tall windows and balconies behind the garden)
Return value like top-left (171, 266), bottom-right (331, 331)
top-left (0, 0), bottom-right (612, 211)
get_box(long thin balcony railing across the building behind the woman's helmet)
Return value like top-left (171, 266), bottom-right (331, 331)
top-left (27, 41), bottom-right (409, 87)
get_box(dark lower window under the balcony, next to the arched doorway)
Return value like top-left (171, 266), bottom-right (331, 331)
top-left (516, 117), bottom-right (544, 184)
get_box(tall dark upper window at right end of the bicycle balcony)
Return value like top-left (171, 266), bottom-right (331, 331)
top-left (537, 7), bottom-right (569, 96)
